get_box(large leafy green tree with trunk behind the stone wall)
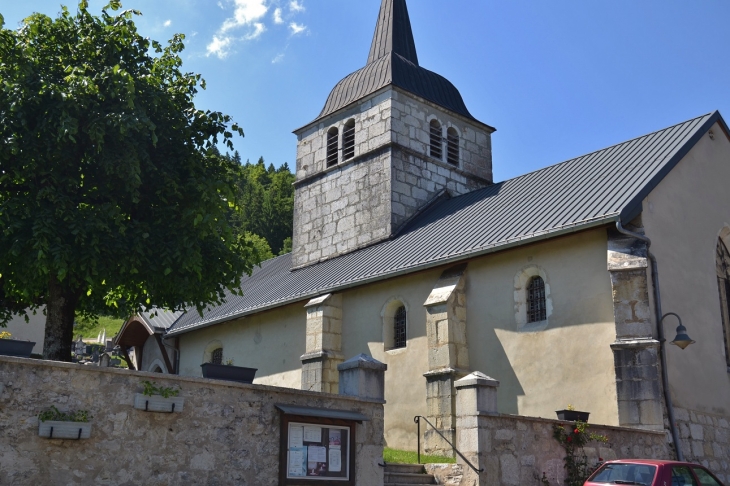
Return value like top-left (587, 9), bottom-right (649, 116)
top-left (0, 0), bottom-right (260, 361)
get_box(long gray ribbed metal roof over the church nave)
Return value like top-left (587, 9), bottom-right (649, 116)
top-left (168, 112), bottom-right (727, 334)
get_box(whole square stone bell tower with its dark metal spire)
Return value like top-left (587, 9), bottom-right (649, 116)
top-left (292, 0), bottom-right (495, 268)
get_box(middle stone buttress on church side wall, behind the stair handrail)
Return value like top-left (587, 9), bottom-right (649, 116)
top-left (423, 265), bottom-right (469, 456)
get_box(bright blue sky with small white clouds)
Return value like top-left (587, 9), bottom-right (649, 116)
top-left (0, 0), bottom-right (730, 181)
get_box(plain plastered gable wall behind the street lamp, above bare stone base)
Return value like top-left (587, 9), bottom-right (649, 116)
top-left (642, 125), bottom-right (730, 416)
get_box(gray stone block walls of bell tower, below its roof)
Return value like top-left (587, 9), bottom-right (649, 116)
top-left (293, 89), bottom-right (492, 268)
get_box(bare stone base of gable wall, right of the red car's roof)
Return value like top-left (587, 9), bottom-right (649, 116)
top-left (674, 407), bottom-right (730, 484)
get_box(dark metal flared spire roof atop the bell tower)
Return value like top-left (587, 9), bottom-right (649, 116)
top-left (314, 0), bottom-right (481, 123)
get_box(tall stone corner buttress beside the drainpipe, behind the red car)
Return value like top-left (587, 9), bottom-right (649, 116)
top-left (608, 230), bottom-right (664, 430)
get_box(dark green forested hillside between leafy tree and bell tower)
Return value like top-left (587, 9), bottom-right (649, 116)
top-left (224, 152), bottom-right (294, 260)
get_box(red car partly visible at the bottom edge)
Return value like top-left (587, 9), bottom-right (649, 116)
top-left (583, 459), bottom-right (723, 486)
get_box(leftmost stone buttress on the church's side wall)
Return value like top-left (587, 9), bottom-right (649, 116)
top-left (301, 294), bottom-right (343, 393)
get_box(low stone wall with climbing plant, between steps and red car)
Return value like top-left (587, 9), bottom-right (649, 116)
top-left (470, 415), bottom-right (671, 486)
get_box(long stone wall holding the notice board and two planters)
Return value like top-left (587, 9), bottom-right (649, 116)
top-left (0, 356), bottom-right (383, 486)
